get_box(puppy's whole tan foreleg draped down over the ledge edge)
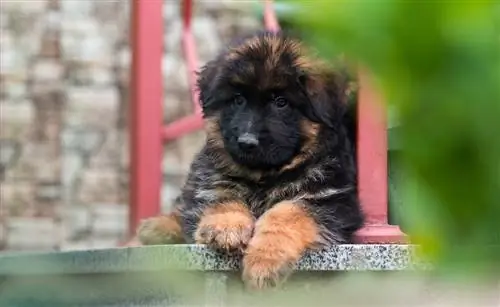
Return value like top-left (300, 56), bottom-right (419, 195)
top-left (243, 201), bottom-right (321, 289)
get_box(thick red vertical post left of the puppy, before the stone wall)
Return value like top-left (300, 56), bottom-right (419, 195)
top-left (129, 0), bottom-right (163, 233)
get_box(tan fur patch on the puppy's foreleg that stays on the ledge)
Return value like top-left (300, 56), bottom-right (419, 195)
top-left (195, 201), bottom-right (254, 250)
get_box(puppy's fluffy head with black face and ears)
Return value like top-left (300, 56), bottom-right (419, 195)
top-left (198, 32), bottom-right (345, 169)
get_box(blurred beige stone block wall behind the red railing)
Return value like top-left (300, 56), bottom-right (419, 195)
top-left (0, 0), bottom-right (260, 250)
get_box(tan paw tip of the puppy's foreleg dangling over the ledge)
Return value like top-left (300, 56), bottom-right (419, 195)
top-left (243, 235), bottom-right (299, 290)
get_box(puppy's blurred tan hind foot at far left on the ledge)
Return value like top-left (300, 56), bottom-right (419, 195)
top-left (137, 209), bottom-right (184, 245)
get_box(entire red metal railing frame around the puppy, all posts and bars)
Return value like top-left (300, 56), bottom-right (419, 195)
top-left (130, 0), bottom-right (405, 243)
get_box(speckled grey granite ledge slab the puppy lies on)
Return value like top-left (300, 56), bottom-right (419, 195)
top-left (0, 244), bottom-right (425, 276)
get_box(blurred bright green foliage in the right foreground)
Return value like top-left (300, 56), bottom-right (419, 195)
top-left (279, 0), bottom-right (500, 275)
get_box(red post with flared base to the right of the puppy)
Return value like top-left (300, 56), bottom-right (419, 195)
top-left (357, 72), bottom-right (405, 243)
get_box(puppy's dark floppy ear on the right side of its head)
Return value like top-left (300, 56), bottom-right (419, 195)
top-left (298, 72), bottom-right (347, 128)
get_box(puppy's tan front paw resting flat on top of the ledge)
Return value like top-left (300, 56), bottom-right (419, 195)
top-left (195, 212), bottom-right (254, 251)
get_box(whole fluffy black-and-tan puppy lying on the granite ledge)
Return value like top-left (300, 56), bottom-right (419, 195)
top-left (138, 32), bottom-right (363, 288)
